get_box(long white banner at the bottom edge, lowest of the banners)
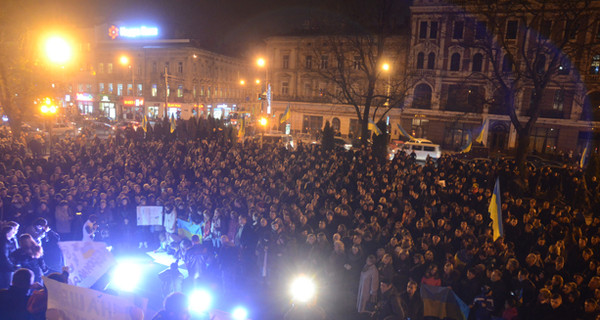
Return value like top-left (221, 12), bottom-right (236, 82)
top-left (44, 277), bottom-right (143, 320)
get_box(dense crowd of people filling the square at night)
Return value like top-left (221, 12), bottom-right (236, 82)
top-left (0, 119), bottom-right (600, 320)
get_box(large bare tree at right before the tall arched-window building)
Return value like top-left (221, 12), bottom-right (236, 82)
top-left (450, 0), bottom-right (598, 177)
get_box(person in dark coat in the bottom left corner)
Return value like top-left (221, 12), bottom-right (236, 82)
top-left (0, 268), bottom-right (33, 320)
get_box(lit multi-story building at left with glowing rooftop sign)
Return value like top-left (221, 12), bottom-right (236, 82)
top-left (66, 25), bottom-right (258, 120)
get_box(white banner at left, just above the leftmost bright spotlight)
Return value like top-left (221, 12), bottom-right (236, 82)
top-left (58, 241), bottom-right (115, 288)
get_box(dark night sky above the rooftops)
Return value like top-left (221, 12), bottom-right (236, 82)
top-left (52, 0), bottom-right (336, 55)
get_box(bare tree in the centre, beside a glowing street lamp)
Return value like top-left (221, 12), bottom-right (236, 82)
top-left (312, 0), bottom-right (414, 143)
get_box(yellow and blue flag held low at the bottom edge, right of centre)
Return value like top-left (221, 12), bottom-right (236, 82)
top-left (421, 284), bottom-right (469, 320)
